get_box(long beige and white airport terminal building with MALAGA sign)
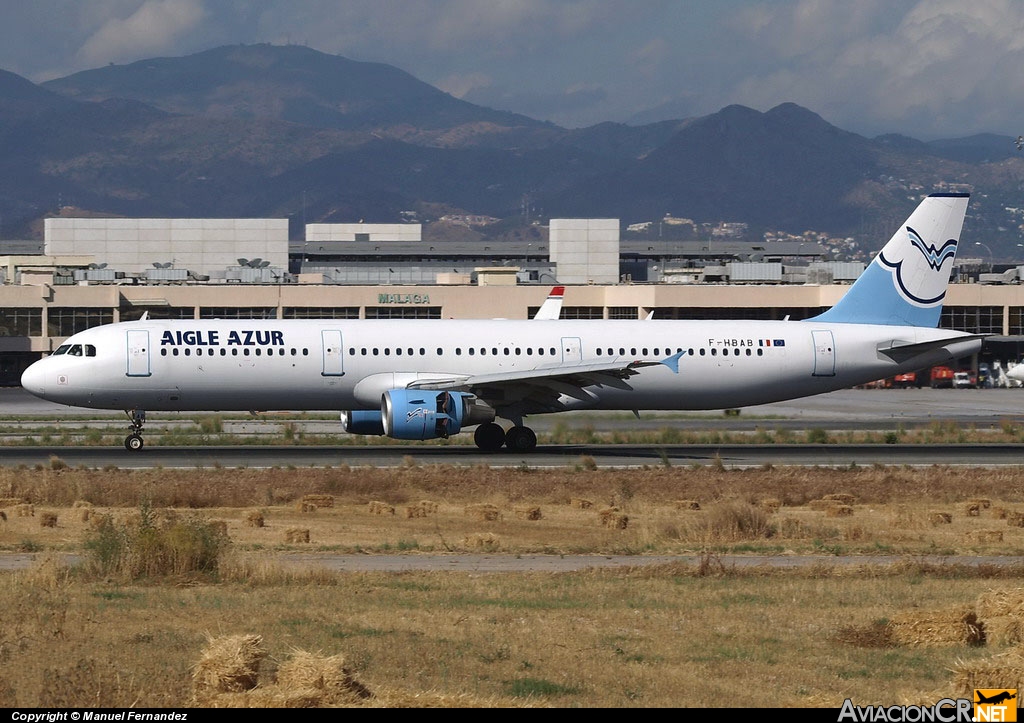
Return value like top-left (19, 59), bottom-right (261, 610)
top-left (0, 213), bottom-right (1024, 384)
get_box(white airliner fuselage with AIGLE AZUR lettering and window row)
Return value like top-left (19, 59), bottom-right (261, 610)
top-left (16, 320), bottom-right (980, 413)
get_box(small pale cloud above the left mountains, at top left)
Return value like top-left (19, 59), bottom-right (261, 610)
top-left (77, 0), bottom-right (207, 66)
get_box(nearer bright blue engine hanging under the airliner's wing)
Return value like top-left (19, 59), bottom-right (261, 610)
top-left (380, 389), bottom-right (495, 439)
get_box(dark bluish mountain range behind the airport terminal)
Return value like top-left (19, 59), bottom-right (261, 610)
top-left (0, 44), bottom-right (1024, 258)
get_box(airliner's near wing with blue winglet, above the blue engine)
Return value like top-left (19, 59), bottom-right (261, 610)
top-left (410, 352), bottom-right (683, 414)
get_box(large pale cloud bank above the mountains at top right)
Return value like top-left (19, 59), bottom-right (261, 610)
top-left (727, 0), bottom-right (1024, 139)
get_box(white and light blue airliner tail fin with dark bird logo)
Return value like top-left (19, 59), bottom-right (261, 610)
top-left (807, 194), bottom-right (970, 327)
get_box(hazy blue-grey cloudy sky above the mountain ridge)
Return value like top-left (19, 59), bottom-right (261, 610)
top-left (0, 0), bottom-right (1024, 140)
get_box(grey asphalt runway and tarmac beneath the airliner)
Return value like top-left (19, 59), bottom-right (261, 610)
top-left (6, 388), bottom-right (1024, 468)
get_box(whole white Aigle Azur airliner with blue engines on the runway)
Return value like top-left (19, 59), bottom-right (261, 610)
top-left (22, 194), bottom-right (982, 451)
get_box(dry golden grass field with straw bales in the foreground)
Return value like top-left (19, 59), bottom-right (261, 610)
top-left (0, 460), bottom-right (1024, 708)
